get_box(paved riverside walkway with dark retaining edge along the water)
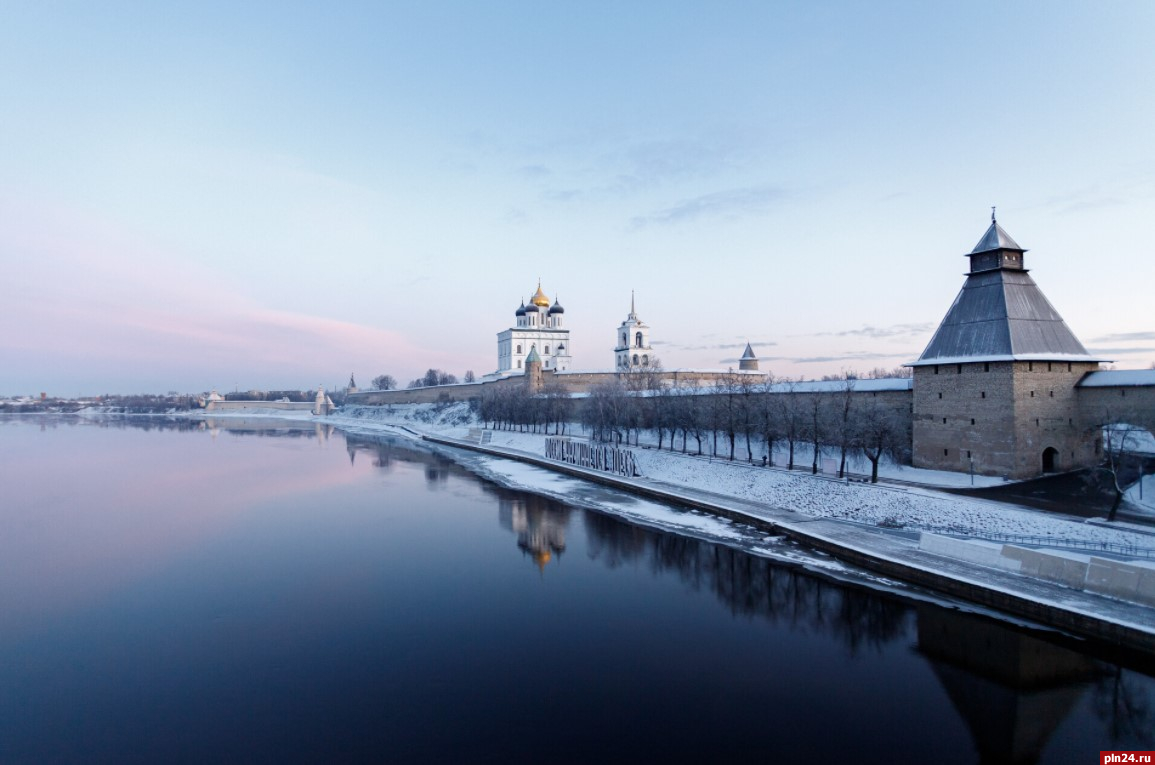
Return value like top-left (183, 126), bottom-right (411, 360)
top-left (422, 429), bottom-right (1155, 654)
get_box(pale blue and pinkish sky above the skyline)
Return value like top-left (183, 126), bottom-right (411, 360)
top-left (0, 0), bottom-right (1155, 396)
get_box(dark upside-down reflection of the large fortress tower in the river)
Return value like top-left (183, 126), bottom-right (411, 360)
top-left (918, 607), bottom-right (1101, 763)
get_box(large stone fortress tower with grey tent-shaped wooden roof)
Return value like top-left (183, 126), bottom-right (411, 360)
top-left (911, 213), bottom-right (1102, 478)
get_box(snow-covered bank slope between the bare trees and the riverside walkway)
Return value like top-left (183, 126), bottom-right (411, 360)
top-left (329, 404), bottom-right (1155, 547)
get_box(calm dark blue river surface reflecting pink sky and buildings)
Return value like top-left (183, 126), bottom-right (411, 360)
top-left (0, 418), bottom-right (1155, 763)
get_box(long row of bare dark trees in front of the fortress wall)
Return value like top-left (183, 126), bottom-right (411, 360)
top-left (478, 367), bottom-right (910, 481)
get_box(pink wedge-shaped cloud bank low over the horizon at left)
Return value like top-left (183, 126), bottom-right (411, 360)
top-left (0, 195), bottom-right (449, 393)
